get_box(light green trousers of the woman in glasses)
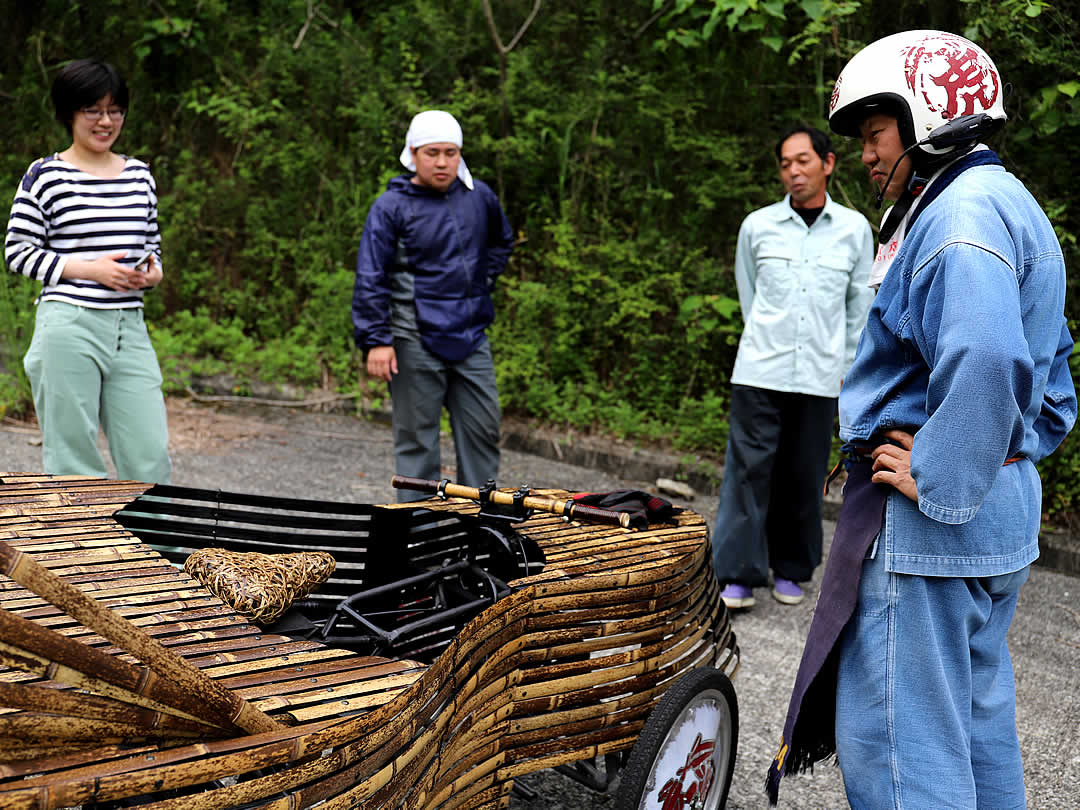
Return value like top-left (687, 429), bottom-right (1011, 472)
top-left (23, 301), bottom-right (172, 484)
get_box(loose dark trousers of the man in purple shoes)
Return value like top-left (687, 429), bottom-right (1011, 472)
top-left (713, 386), bottom-right (836, 588)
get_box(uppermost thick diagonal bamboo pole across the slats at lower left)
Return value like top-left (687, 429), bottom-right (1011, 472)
top-left (0, 540), bottom-right (280, 733)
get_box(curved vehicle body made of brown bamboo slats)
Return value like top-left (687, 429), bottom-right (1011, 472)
top-left (0, 475), bottom-right (739, 810)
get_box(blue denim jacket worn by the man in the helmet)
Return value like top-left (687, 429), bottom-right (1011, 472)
top-left (839, 159), bottom-right (1077, 577)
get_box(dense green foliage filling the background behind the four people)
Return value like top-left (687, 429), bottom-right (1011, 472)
top-left (6, 0), bottom-right (1080, 522)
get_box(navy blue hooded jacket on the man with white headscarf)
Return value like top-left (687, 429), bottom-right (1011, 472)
top-left (352, 175), bottom-right (514, 363)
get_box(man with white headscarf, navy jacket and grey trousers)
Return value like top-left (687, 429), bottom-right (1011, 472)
top-left (352, 110), bottom-right (513, 500)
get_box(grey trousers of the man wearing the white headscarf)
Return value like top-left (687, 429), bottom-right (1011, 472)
top-left (390, 336), bottom-right (502, 501)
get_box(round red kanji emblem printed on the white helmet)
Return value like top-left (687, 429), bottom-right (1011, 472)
top-left (904, 35), bottom-right (1001, 121)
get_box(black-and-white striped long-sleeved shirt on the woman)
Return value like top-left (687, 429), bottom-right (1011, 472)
top-left (4, 154), bottom-right (161, 309)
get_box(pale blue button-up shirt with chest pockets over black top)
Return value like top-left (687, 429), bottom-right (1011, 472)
top-left (731, 195), bottom-right (874, 396)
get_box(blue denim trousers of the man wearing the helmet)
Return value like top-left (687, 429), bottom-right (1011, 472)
top-left (836, 538), bottom-right (1028, 810)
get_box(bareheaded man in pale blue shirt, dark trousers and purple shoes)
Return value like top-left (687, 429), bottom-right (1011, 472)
top-left (713, 125), bottom-right (874, 608)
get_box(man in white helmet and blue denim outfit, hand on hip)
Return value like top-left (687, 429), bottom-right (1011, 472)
top-left (768, 31), bottom-right (1077, 808)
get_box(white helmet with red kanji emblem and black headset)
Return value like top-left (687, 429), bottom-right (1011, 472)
top-left (828, 31), bottom-right (1005, 159)
